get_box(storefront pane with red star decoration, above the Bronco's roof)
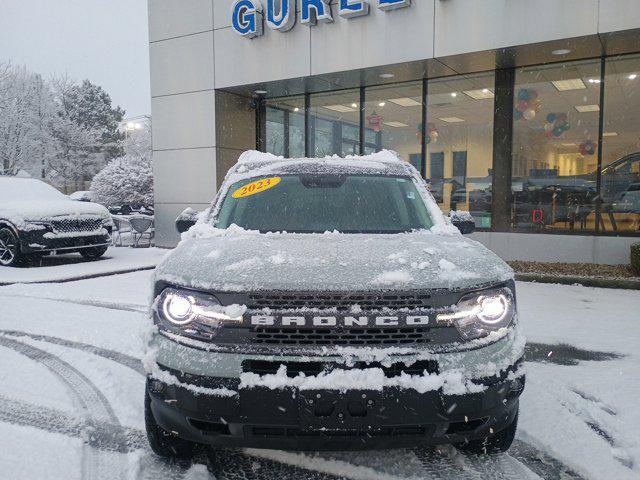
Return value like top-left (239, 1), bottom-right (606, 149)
top-left (365, 82), bottom-right (422, 171)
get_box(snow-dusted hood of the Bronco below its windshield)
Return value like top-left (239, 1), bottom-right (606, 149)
top-left (156, 224), bottom-right (513, 292)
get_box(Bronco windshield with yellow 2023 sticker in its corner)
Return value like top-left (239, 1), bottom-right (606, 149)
top-left (216, 174), bottom-right (433, 233)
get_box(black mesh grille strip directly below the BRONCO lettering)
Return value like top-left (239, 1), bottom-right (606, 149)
top-left (252, 326), bottom-right (432, 346)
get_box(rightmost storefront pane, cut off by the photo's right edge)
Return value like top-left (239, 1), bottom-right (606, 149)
top-left (600, 55), bottom-right (640, 234)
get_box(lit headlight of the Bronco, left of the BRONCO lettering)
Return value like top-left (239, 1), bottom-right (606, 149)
top-left (156, 288), bottom-right (246, 339)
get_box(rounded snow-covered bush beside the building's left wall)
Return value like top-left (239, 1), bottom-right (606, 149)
top-left (91, 155), bottom-right (153, 207)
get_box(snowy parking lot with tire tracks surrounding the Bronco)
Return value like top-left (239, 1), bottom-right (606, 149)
top-left (0, 262), bottom-right (640, 480)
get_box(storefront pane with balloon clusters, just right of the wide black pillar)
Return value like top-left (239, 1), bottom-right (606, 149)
top-left (511, 60), bottom-right (600, 231)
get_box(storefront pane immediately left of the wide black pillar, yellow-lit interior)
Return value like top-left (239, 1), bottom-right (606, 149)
top-left (425, 73), bottom-right (495, 228)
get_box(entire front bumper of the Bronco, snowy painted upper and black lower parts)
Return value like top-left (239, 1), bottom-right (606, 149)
top-left (147, 334), bottom-right (524, 450)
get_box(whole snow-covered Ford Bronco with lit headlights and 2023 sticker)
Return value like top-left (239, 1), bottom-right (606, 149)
top-left (145, 151), bottom-right (524, 457)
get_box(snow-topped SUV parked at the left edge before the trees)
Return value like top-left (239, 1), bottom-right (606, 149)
top-left (0, 177), bottom-right (113, 266)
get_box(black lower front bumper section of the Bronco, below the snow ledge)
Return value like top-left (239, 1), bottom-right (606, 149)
top-left (147, 376), bottom-right (524, 451)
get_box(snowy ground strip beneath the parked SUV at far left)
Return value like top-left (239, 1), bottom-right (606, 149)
top-left (0, 247), bottom-right (168, 285)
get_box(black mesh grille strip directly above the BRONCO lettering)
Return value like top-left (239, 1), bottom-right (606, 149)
top-left (248, 292), bottom-right (431, 311)
